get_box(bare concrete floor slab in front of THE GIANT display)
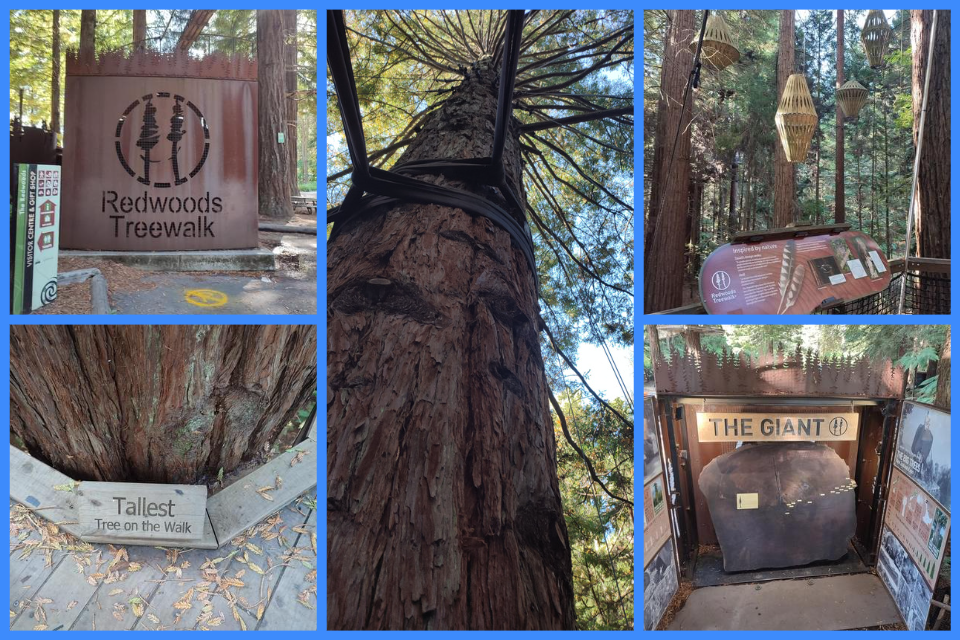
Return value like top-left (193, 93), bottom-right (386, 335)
top-left (670, 573), bottom-right (900, 631)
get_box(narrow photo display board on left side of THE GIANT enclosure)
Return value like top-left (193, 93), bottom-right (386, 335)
top-left (643, 398), bottom-right (680, 631)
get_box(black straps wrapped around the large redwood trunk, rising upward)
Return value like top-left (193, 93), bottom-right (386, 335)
top-left (327, 10), bottom-right (539, 284)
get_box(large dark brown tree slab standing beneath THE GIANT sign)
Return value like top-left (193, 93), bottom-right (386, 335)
top-left (698, 442), bottom-right (857, 571)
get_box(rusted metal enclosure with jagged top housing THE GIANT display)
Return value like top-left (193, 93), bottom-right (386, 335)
top-left (644, 327), bottom-right (905, 584)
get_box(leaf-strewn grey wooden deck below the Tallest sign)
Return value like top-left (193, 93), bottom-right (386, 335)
top-left (10, 490), bottom-right (317, 631)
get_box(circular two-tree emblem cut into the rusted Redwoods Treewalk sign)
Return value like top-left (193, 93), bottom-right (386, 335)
top-left (115, 91), bottom-right (210, 189)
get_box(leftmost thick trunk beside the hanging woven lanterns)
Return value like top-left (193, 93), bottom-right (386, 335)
top-left (643, 10), bottom-right (695, 313)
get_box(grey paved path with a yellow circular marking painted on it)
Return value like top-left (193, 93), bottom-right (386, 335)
top-left (110, 272), bottom-right (317, 315)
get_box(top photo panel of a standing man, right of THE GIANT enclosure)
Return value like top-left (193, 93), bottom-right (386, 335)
top-left (895, 402), bottom-right (950, 511)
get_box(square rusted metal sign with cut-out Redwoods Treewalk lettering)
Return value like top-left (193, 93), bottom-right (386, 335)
top-left (61, 53), bottom-right (258, 251)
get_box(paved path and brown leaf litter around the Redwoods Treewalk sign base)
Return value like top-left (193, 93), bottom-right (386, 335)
top-left (33, 214), bottom-right (317, 315)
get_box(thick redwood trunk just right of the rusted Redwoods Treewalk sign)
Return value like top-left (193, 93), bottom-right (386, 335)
top-left (257, 9), bottom-right (293, 219)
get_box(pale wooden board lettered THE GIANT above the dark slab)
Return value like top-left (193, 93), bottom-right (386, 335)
top-left (697, 413), bottom-right (860, 442)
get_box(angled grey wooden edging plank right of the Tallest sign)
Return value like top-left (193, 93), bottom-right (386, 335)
top-left (207, 432), bottom-right (317, 545)
